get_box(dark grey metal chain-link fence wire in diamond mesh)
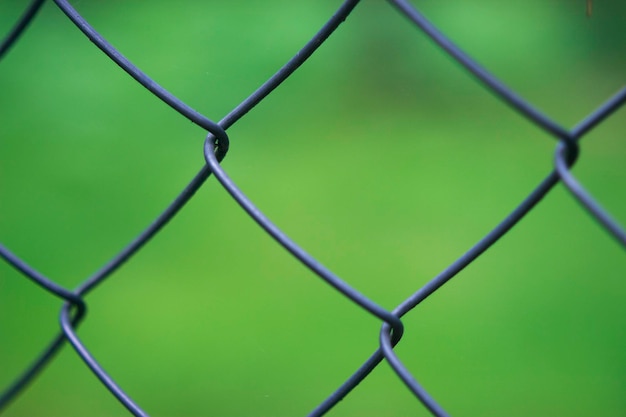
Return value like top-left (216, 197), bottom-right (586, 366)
top-left (0, 0), bottom-right (626, 416)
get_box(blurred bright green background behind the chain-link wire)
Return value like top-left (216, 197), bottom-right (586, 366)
top-left (0, 0), bottom-right (626, 417)
